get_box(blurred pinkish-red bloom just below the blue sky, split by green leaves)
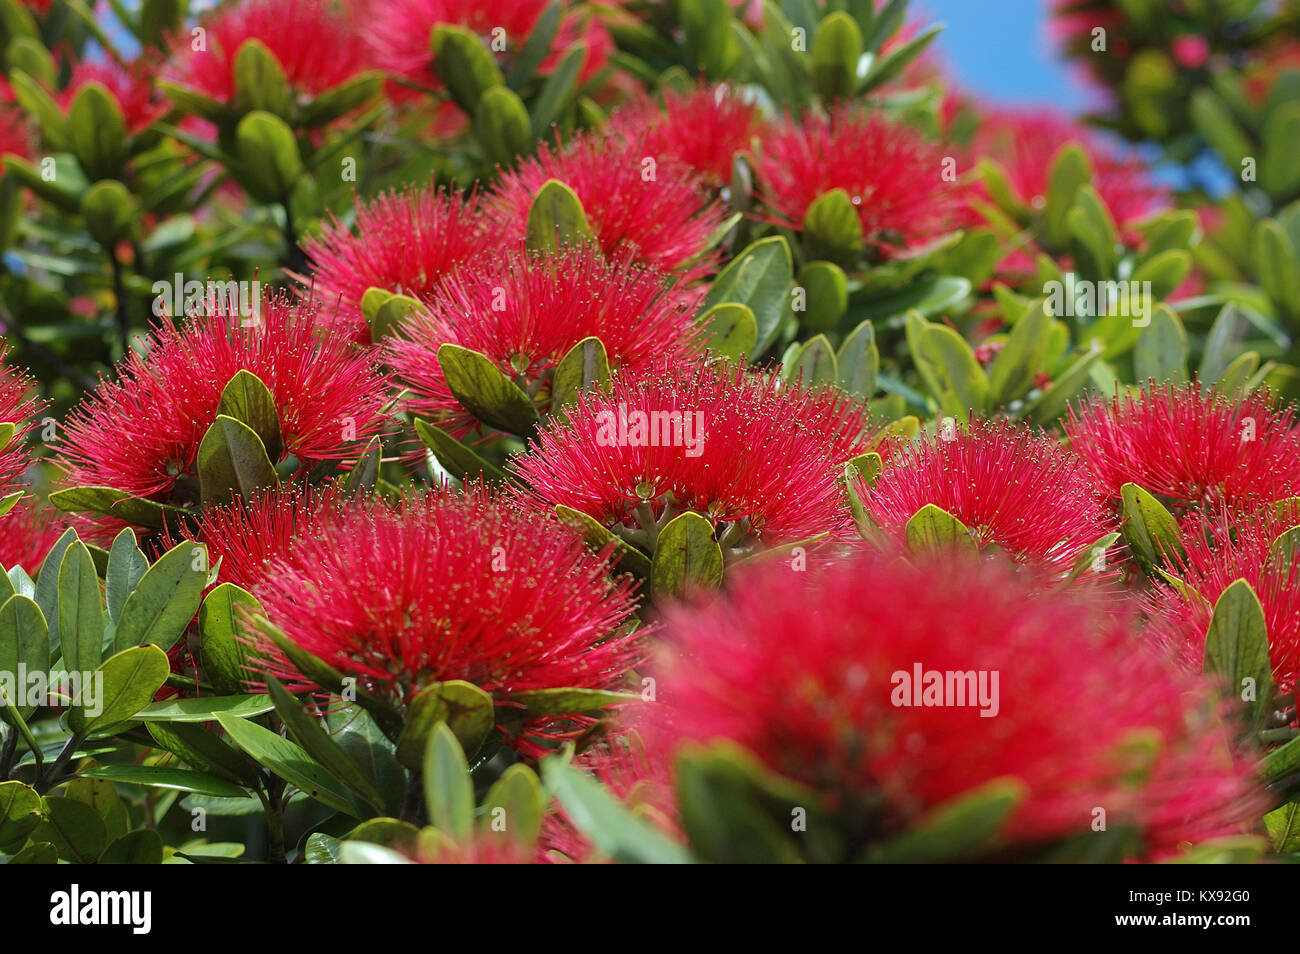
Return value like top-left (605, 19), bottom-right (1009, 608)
top-left (971, 109), bottom-right (1169, 242)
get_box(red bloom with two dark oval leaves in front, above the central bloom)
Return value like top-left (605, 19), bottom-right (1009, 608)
top-left (384, 246), bottom-right (699, 434)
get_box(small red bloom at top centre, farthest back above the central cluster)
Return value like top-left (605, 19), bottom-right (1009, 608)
top-left (607, 86), bottom-right (761, 188)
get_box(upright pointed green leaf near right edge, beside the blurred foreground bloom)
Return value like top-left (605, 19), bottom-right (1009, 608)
top-left (1203, 580), bottom-right (1273, 725)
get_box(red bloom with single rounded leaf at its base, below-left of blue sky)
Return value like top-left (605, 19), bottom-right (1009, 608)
top-left (757, 109), bottom-right (958, 251)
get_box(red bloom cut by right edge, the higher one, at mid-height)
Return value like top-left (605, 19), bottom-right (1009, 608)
top-left (1066, 382), bottom-right (1300, 522)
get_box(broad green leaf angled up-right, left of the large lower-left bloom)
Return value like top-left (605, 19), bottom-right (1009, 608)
top-left (113, 541), bottom-right (208, 652)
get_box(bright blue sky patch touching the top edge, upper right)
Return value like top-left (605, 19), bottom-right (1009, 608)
top-left (909, 0), bottom-right (1087, 113)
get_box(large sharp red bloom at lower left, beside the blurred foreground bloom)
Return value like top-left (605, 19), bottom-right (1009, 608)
top-left (245, 491), bottom-right (640, 749)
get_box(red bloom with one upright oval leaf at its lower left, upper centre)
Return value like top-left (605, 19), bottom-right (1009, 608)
top-left (484, 133), bottom-right (723, 280)
